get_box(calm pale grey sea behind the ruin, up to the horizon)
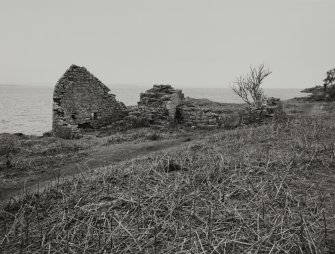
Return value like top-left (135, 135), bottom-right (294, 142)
top-left (0, 85), bottom-right (304, 135)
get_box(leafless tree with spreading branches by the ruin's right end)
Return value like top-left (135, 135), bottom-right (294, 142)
top-left (232, 64), bottom-right (271, 108)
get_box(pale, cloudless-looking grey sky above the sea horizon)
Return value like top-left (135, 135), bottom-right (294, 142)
top-left (0, 0), bottom-right (335, 88)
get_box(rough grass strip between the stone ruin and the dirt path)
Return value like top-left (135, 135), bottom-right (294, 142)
top-left (0, 128), bottom-right (182, 190)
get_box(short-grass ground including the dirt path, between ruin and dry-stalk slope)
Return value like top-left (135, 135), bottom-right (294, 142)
top-left (0, 128), bottom-right (194, 198)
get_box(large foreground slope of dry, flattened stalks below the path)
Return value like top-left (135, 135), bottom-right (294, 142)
top-left (0, 110), bottom-right (335, 253)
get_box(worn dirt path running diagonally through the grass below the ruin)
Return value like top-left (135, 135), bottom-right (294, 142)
top-left (0, 135), bottom-right (196, 202)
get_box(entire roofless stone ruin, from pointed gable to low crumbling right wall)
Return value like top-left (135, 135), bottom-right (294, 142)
top-left (52, 65), bottom-right (283, 138)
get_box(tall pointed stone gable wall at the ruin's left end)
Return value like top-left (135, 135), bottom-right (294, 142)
top-left (52, 65), bottom-right (127, 138)
